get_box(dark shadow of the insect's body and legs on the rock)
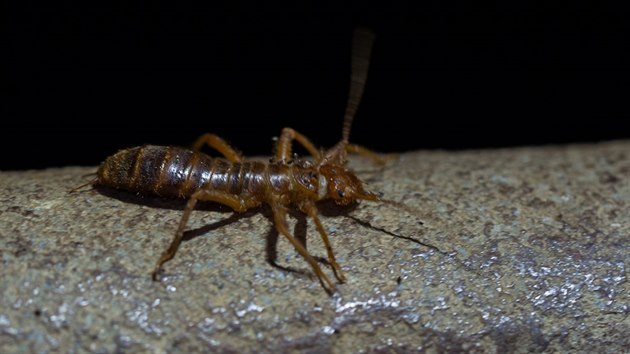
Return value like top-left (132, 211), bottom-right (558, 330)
top-left (94, 185), bottom-right (362, 279)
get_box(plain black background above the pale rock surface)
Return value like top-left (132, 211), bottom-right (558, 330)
top-left (6, 1), bottom-right (630, 170)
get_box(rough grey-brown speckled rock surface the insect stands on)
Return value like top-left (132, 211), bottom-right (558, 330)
top-left (0, 141), bottom-right (630, 353)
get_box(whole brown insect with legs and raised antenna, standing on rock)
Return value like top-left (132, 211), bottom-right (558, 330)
top-left (74, 29), bottom-right (397, 294)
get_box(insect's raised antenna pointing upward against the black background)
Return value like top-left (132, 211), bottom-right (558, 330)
top-left (341, 28), bottom-right (374, 144)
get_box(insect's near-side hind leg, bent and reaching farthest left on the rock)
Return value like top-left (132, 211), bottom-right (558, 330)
top-left (151, 189), bottom-right (251, 280)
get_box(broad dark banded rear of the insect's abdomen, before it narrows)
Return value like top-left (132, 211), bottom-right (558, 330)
top-left (97, 145), bottom-right (216, 198)
